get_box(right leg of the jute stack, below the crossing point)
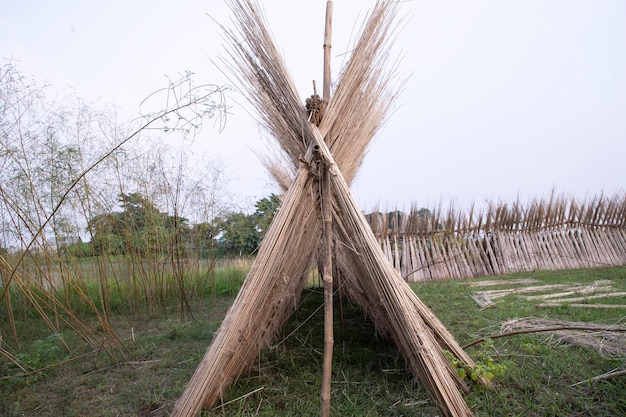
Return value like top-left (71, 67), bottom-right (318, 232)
top-left (312, 127), bottom-right (472, 416)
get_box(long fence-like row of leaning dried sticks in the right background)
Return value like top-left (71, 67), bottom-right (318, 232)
top-left (366, 193), bottom-right (626, 281)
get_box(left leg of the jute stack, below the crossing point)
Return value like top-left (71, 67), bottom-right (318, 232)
top-left (172, 162), bottom-right (321, 416)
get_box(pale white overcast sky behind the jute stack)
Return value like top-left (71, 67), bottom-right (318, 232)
top-left (0, 0), bottom-right (626, 210)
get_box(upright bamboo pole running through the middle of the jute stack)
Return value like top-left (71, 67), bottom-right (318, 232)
top-left (321, 1), bottom-right (335, 417)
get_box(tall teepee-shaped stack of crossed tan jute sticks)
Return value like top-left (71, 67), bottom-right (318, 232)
top-left (172, 0), bottom-right (482, 417)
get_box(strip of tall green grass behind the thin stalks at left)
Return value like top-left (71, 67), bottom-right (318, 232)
top-left (0, 256), bottom-right (252, 321)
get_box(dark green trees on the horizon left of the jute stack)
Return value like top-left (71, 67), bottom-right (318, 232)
top-left (60, 193), bottom-right (280, 259)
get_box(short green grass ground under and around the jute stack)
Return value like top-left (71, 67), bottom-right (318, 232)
top-left (0, 267), bottom-right (626, 416)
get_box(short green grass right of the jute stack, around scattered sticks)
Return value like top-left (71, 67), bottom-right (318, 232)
top-left (414, 268), bottom-right (626, 416)
